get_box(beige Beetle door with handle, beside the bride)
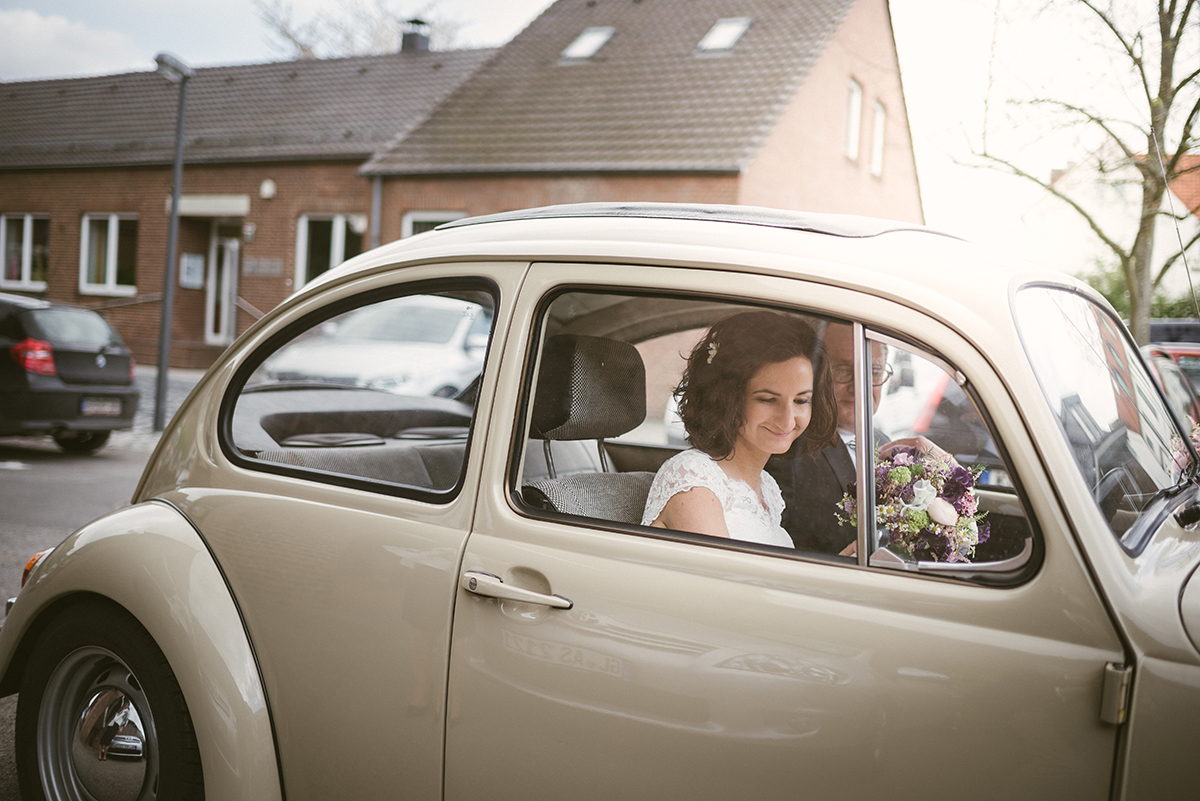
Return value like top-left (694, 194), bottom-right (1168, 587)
top-left (445, 265), bottom-right (1123, 800)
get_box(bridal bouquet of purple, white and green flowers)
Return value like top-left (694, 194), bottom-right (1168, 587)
top-left (838, 447), bottom-right (988, 562)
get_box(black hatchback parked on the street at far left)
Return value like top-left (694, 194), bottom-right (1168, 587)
top-left (0, 293), bottom-right (139, 453)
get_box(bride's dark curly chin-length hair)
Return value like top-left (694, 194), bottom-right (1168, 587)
top-left (674, 312), bottom-right (838, 459)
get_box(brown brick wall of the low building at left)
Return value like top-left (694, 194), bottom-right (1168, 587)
top-left (0, 162), bottom-right (371, 367)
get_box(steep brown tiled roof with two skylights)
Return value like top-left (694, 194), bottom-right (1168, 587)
top-left (364, 0), bottom-right (854, 174)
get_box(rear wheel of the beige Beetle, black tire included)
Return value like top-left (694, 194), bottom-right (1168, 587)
top-left (16, 603), bottom-right (204, 801)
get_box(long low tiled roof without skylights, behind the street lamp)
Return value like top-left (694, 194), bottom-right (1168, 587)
top-left (0, 50), bottom-right (494, 169)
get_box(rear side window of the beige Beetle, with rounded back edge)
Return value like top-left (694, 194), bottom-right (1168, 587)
top-left (228, 289), bottom-right (496, 501)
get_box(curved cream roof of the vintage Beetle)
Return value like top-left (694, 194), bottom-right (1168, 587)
top-left (302, 203), bottom-right (1108, 352)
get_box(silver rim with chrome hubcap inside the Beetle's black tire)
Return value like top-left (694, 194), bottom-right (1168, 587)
top-left (37, 646), bottom-right (158, 801)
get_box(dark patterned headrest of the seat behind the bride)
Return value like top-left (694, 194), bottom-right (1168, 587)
top-left (533, 335), bottom-right (646, 440)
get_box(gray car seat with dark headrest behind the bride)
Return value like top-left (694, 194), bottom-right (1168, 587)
top-left (522, 335), bottom-right (654, 524)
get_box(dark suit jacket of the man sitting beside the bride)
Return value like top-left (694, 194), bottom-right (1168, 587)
top-left (767, 441), bottom-right (857, 554)
